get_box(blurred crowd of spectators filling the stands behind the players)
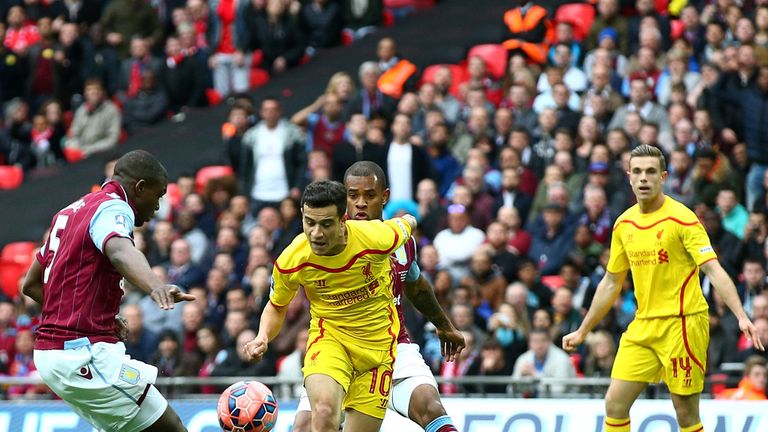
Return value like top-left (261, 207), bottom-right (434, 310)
top-left (0, 0), bottom-right (768, 398)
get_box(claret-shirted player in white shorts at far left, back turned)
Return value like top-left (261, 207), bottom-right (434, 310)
top-left (22, 150), bottom-right (195, 432)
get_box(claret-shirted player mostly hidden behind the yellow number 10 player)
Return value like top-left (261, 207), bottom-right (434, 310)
top-left (292, 161), bottom-right (464, 432)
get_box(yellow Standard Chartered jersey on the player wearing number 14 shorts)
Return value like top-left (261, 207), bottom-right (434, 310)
top-left (608, 196), bottom-right (717, 318)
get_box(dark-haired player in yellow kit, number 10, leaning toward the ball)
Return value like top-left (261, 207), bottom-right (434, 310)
top-left (244, 181), bottom-right (416, 432)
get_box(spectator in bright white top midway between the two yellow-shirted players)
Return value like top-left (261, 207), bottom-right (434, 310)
top-left (434, 204), bottom-right (485, 280)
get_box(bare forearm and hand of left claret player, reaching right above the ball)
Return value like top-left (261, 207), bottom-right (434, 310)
top-left (104, 237), bottom-right (195, 310)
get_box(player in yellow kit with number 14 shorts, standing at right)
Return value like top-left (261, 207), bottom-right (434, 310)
top-left (563, 145), bottom-right (764, 432)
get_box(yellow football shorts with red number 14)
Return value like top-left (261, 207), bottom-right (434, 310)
top-left (611, 312), bottom-right (709, 395)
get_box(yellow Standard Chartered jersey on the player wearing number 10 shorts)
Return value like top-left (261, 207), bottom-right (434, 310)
top-left (269, 218), bottom-right (411, 350)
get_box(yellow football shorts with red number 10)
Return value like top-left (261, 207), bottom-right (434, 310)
top-left (302, 332), bottom-right (396, 419)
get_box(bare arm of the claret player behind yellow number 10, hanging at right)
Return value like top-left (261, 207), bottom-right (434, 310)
top-left (405, 275), bottom-right (466, 361)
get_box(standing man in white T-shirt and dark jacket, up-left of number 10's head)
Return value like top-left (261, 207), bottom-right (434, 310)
top-left (238, 97), bottom-right (307, 214)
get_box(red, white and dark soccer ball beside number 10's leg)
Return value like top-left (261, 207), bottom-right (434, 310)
top-left (218, 381), bottom-right (277, 432)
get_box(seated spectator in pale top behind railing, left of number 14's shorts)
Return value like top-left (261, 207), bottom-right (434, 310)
top-left (512, 328), bottom-right (576, 394)
